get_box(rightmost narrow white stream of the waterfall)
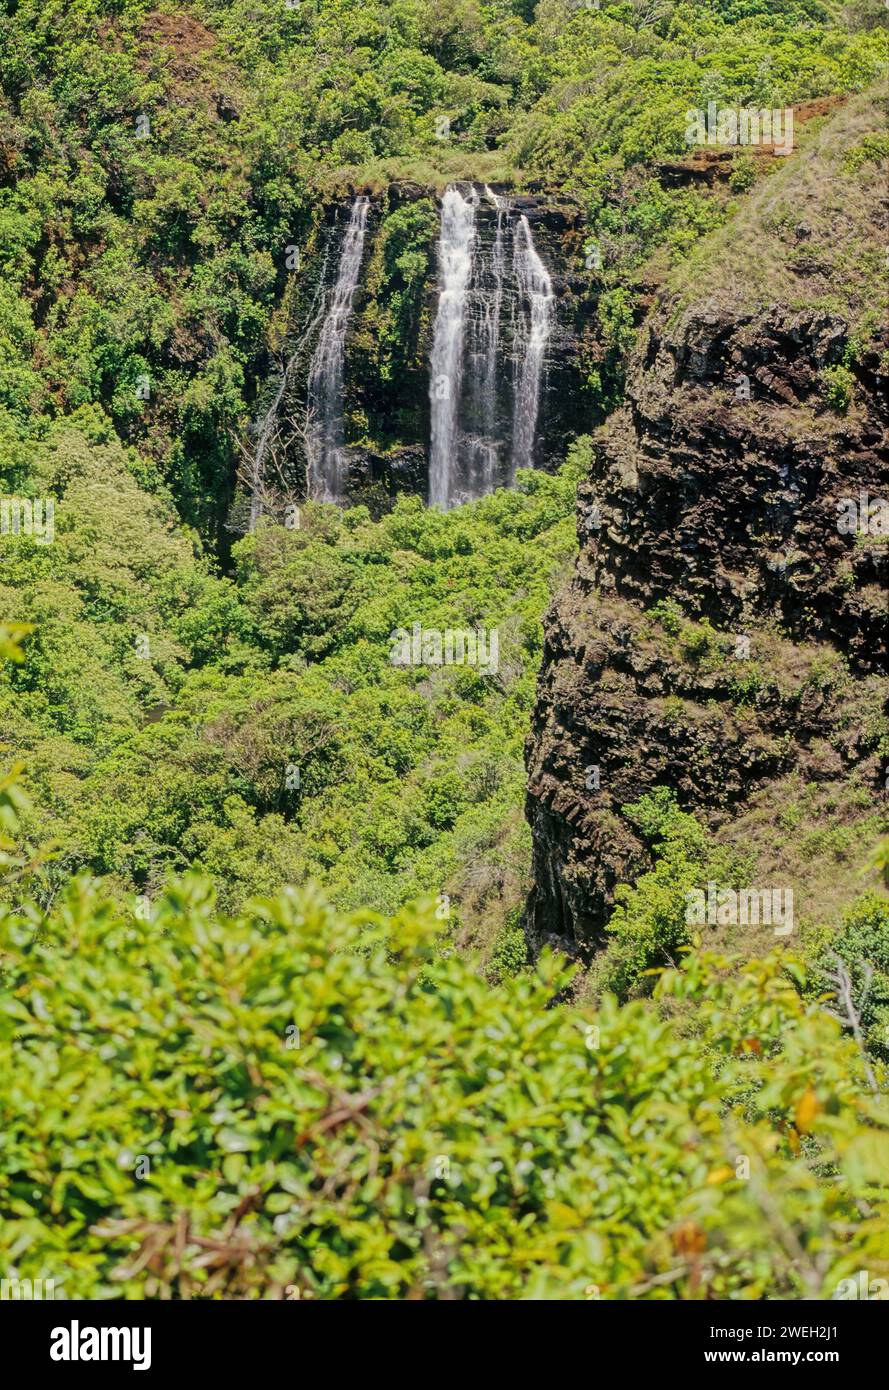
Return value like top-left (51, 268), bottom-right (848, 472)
top-left (510, 214), bottom-right (556, 481)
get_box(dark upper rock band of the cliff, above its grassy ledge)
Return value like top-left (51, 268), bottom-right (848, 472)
top-left (578, 306), bottom-right (888, 670)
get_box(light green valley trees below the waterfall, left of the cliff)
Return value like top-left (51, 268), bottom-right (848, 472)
top-left (0, 425), bottom-right (589, 931)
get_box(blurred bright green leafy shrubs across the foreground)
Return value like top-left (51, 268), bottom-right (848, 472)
top-left (0, 876), bottom-right (889, 1300)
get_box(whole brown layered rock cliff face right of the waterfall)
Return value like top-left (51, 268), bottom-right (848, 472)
top-left (526, 95), bottom-right (889, 948)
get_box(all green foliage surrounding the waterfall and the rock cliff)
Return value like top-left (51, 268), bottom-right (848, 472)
top-left (0, 0), bottom-right (889, 1300)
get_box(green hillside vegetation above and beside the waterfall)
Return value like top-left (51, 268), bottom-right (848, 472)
top-left (0, 0), bottom-right (886, 525)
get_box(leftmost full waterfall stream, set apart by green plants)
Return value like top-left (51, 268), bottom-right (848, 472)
top-left (306, 197), bottom-right (369, 502)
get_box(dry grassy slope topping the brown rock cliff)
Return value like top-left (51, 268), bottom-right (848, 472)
top-left (672, 90), bottom-right (886, 331)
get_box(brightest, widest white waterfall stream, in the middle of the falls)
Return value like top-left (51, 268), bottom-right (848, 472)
top-left (429, 188), bottom-right (478, 507)
